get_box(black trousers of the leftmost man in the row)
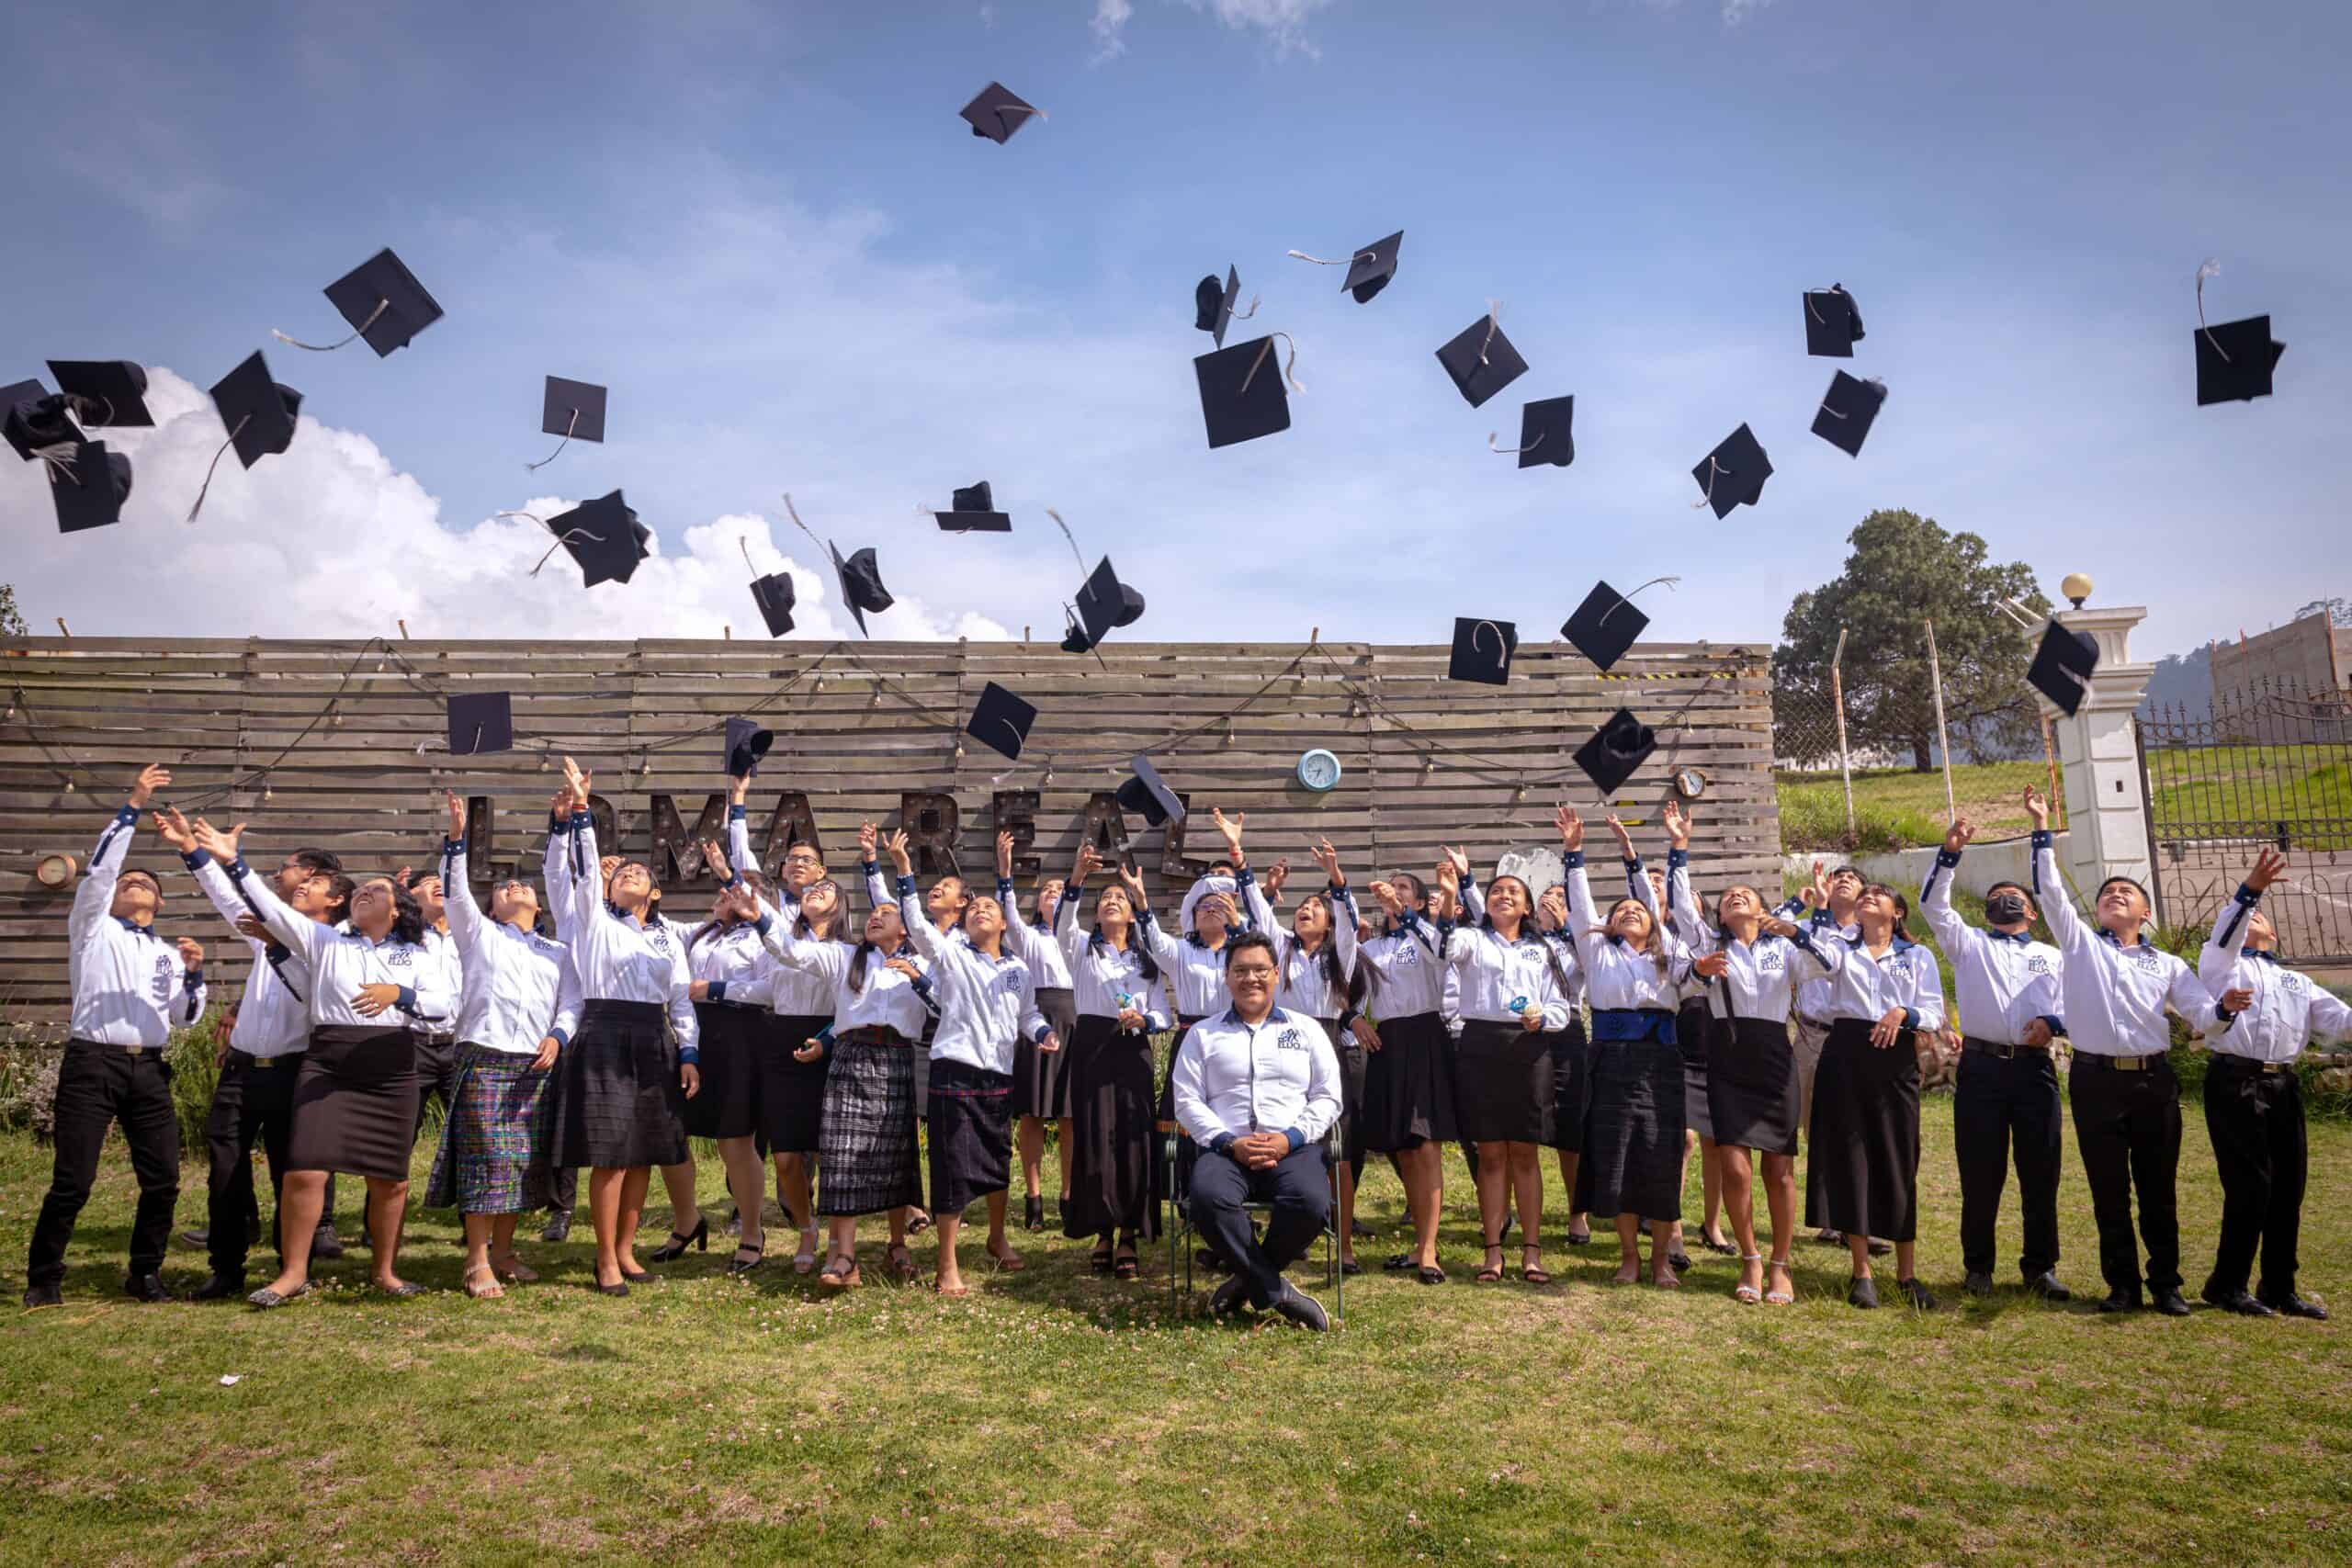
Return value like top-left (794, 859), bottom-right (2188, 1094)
top-left (24, 1039), bottom-right (179, 1286)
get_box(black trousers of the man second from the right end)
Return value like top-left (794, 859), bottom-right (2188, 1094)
top-left (2067, 1051), bottom-right (2180, 1291)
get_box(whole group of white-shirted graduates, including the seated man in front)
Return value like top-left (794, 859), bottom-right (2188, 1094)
top-left (26, 760), bottom-right (2352, 1328)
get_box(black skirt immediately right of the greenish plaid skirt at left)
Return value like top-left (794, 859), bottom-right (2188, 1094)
top-left (548, 999), bottom-right (687, 1170)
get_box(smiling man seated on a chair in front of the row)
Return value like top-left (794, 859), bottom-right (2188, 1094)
top-left (1171, 931), bottom-right (1340, 1331)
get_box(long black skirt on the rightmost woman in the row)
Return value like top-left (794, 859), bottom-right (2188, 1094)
top-left (1804, 1018), bottom-right (1919, 1241)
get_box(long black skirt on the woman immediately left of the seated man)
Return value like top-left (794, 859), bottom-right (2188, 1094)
top-left (1061, 1013), bottom-right (1159, 1241)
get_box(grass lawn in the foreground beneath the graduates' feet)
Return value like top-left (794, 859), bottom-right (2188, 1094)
top-left (0, 1098), bottom-right (2352, 1563)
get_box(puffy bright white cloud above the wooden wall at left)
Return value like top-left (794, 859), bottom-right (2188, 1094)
top-left (0, 367), bottom-right (1007, 639)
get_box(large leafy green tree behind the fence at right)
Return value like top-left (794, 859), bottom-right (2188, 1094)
top-left (1771, 510), bottom-right (2049, 773)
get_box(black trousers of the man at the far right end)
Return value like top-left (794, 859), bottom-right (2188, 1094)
top-left (2204, 1054), bottom-right (2310, 1304)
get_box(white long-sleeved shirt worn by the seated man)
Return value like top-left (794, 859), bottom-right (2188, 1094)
top-left (1169, 1006), bottom-right (1340, 1149)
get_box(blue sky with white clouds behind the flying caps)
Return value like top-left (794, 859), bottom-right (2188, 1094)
top-left (0, 0), bottom-right (2352, 656)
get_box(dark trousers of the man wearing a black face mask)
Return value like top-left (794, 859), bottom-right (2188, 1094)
top-left (1952, 1039), bottom-right (2058, 1279)
